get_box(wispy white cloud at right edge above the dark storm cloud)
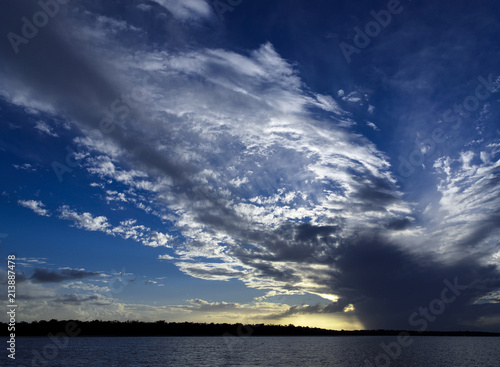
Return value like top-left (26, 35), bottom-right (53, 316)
top-left (416, 146), bottom-right (500, 265)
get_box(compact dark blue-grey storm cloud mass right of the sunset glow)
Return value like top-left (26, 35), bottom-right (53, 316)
top-left (324, 234), bottom-right (500, 330)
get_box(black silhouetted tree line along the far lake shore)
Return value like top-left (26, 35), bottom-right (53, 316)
top-left (0, 319), bottom-right (500, 337)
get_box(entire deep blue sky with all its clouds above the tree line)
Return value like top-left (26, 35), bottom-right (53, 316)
top-left (0, 0), bottom-right (500, 331)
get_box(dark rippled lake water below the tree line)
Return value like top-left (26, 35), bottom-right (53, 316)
top-left (8, 336), bottom-right (500, 367)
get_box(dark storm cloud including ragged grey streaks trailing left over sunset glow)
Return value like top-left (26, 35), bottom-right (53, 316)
top-left (239, 227), bottom-right (500, 330)
